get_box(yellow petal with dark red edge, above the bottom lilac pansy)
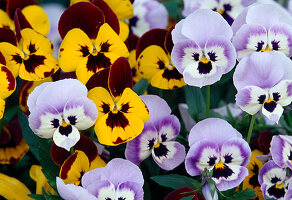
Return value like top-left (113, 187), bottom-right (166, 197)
top-left (59, 150), bottom-right (89, 185)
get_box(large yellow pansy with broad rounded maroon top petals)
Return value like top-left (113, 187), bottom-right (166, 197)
top-left (59, 1), bottom-right (129, 84)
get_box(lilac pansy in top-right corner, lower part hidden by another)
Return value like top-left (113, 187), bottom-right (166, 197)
top-left (232, 3), bottom-right (292, 59)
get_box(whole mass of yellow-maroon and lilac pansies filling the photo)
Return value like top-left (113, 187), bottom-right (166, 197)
top-left (0, 0), bottom-right (292, 200)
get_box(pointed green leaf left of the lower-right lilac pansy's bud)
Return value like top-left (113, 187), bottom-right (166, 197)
top-left (151, 174), bottom-right (200, 189)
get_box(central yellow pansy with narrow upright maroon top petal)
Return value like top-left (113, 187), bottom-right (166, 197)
top-left (88, 57), bottom-right (149, 145)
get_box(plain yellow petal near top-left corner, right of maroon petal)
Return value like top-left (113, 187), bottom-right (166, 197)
top-left (22, 5), bottom-right (50, 35)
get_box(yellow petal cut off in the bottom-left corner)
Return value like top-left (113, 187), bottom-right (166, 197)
top-left (0, 173), bottom-right (32, 200)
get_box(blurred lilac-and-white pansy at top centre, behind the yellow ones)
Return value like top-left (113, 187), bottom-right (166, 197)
top-left (130, 0), bottom-right (168, 37)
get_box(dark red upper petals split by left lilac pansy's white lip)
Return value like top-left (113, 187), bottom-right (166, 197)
top-left (51, 134), bottom-right (98, 166)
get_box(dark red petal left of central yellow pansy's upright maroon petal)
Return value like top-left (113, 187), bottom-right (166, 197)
top-left (85, 68), bottom-right (110, 91)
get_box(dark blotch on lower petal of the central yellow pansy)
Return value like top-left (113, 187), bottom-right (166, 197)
top-left (106, 111), bottom-right (129, 129)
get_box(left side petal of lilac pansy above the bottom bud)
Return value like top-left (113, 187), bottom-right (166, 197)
top-left (185, 140), bottom-right (220, 176)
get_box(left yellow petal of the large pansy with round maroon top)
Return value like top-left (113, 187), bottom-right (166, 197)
top-left (59, 28), bottom-right (93, 72)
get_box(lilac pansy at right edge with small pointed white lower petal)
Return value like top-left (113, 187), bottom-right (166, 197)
top-left (233, 52), bottom-right (292, 122)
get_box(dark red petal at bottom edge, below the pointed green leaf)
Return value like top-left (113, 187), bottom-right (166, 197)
top-left (163, 187), bottom-right (205, 200)
